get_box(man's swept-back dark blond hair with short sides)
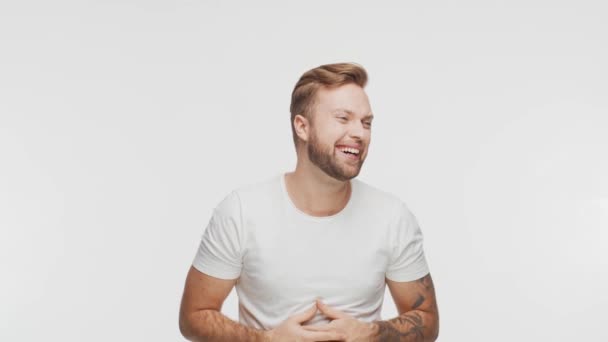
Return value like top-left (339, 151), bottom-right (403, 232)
top-left (289, 63), bottom-right (367, 145)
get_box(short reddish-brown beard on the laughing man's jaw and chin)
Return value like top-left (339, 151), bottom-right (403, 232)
top-left (307, 132), bottom-right (363, 182)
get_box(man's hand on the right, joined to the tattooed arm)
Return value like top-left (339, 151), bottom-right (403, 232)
top-left (302, 300), bottom-right (373, 342)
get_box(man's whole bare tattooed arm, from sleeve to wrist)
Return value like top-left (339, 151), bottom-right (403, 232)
top-left (372, 274), bottom-right (439, 342)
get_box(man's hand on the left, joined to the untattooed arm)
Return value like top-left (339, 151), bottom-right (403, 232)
top-left (266, 303), bottom-right (346, 342)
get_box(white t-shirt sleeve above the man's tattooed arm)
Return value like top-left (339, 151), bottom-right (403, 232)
top-left (386, 203), bottom-right (429, 282)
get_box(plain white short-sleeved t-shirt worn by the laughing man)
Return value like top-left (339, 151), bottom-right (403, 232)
top-left (192, 174), bottom-right (429, 330)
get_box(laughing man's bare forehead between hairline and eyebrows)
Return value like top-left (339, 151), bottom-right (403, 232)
top-left (315, 84), bottom-right (371, 116)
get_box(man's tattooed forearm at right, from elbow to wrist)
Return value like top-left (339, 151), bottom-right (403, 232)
top-left (372, 310), bottom-right (439, 342)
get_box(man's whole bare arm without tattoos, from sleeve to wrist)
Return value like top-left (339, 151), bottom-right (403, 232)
top-left (179, 266), bottom-right (266, 342)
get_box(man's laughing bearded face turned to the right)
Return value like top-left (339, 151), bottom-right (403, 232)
top-left (306, 84), bottom-right (373, 181)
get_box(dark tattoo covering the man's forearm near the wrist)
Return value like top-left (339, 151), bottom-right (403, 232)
top-left (375, 312), bottom-right (424, 342)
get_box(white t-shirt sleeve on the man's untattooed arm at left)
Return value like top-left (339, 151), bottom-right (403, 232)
top-left (192, 191), bottom-right (244, 279)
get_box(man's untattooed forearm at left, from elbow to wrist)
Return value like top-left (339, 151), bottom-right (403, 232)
top-left (180, 310), bottom-right (266, 342)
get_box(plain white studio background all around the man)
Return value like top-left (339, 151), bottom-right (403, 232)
top-left (0, 1), bottom-right (608, 342)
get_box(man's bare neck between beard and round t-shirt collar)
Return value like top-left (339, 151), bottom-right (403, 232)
top-left (285, 155), bottom-right (351, 216)
